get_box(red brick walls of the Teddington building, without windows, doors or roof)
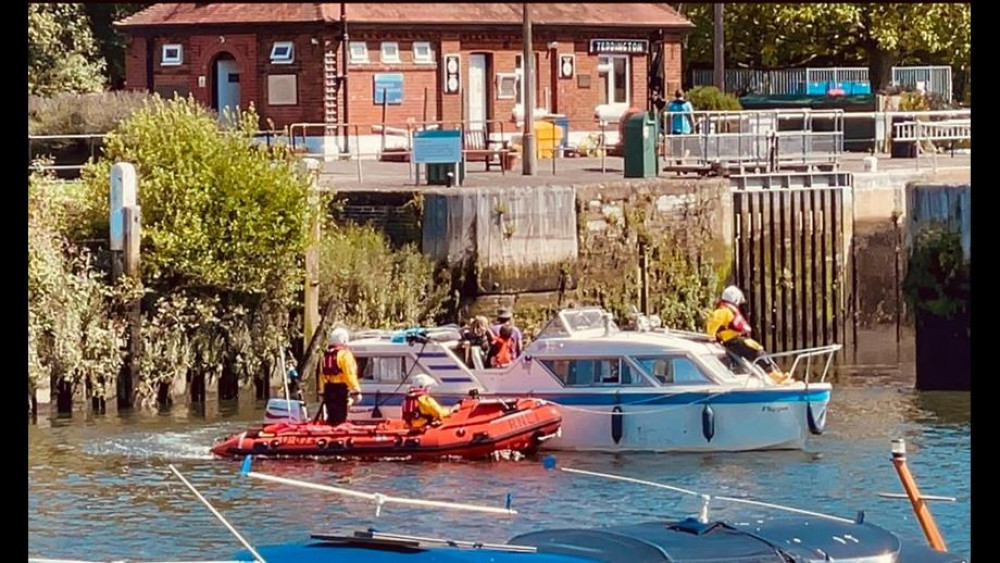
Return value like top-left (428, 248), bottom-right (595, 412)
top-left (126, 29), bottom-right (682, 134)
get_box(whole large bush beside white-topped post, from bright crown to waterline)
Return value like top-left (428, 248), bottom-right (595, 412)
top-left (79, 96), bottom-right (311, 404)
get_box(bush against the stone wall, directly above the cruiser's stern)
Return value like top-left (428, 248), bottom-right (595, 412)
top-left (320, 225), bottom-right (447, 328)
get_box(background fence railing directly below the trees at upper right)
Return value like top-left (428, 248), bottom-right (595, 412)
top-left (691, 66), bottom-right (952, 102)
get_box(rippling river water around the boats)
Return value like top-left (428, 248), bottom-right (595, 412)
top-left (28, 367), bottom-right (971, 561)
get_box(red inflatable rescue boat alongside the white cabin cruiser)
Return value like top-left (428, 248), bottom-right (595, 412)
top-left (212, 398), bottom-right (562, 460)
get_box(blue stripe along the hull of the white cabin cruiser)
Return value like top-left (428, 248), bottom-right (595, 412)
top-left (358, 389), bottom-right (830, 407)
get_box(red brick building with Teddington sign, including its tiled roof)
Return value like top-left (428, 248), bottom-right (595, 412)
top-left (116, 3), bottom-right (693, 159)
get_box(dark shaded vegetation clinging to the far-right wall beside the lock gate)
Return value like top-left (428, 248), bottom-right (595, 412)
top-left (903, 225), bottom-right (970, 318)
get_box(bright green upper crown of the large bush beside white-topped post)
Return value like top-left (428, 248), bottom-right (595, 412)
top-left (84, 97), bottom-right (309, 295)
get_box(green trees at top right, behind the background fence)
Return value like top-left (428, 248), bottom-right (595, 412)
top-left (673, 3), bottom-right (972, 89)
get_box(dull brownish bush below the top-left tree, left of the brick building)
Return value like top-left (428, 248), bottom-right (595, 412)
top-left (28, 92), bottom-right (150, 135)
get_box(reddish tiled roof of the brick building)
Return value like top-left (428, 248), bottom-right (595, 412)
top-left (117, 2), bottom-right (694, 28)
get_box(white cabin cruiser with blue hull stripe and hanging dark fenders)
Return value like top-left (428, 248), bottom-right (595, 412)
top-left (336, 308), bottom-right (840, 452)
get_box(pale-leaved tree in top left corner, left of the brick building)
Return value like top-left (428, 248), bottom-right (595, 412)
top-left (28, 4), bottom-right (104, 96)
